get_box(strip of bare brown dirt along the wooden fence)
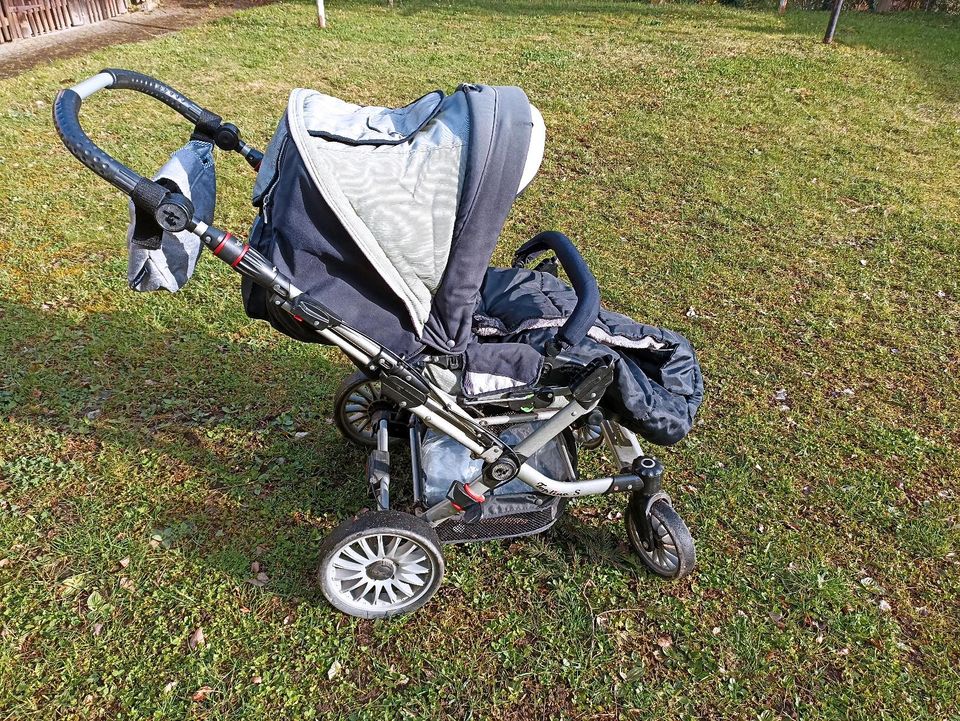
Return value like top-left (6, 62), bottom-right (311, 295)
top-left (0, 0), bottom-right (273, 78)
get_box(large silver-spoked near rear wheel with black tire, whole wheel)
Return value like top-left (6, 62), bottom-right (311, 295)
top-left (319, 511), bottom-right (444, 618)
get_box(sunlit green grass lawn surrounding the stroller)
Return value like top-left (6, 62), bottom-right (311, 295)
top-left (0, 0), bottom-right (960, 721)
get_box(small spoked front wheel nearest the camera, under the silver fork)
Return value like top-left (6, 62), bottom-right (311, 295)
top-left (625, 493), bottom-right (697, 579)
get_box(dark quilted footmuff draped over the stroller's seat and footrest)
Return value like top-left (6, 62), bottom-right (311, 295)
top-left (473, 268), bottom-right (703, 446)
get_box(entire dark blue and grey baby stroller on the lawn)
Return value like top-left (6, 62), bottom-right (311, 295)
top-left (53, 70), bottom-right (703, 618)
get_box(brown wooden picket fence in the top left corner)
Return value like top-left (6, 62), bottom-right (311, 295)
top-left (0, 0), bottom-right (127, 43)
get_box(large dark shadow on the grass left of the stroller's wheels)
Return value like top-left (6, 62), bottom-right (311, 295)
top-left (0, 296), bottom-right (376, 597)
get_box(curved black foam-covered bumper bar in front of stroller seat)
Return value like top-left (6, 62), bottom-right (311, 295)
top-left (513, 230), bottom-right (600, 347)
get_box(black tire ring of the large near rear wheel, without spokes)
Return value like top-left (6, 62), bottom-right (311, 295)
top-left (317, 511), bottom-right (444, 618)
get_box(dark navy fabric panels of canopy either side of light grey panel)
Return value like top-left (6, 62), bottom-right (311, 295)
top-left (243, 85), bottom-right (532, 355)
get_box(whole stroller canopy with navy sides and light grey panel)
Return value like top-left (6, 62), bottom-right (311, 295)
top-left (245, 85), bottom-right (544, 353)
